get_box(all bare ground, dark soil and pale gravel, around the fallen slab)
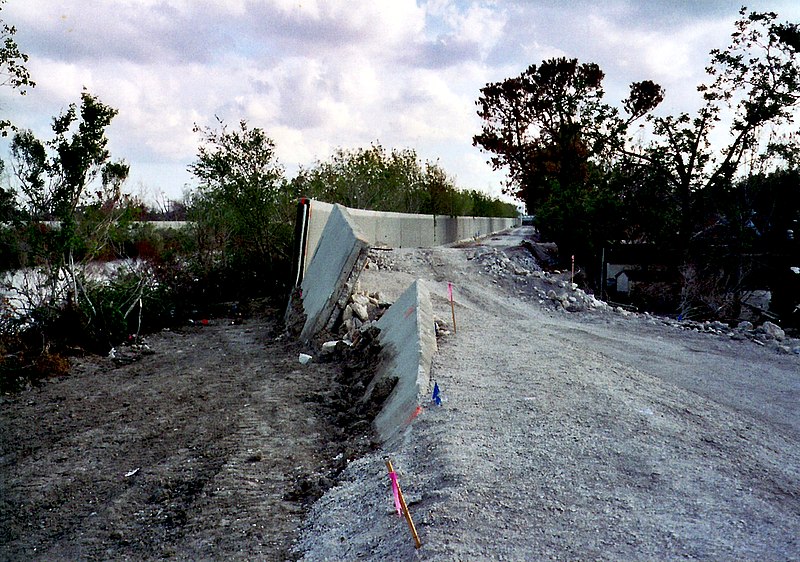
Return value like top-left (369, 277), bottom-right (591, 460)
top-left (0, 232), bottom-right (800, 560)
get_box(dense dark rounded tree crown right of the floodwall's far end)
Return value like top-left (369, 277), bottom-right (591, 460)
top-left (473, 58), bottom-right (663, 213)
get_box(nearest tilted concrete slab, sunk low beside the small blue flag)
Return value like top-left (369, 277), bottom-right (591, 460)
top-left (367, 280), bottom-right (436, 442)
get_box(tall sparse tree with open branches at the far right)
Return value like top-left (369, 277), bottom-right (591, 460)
top-left (628, 8), bottom-right (800, 250)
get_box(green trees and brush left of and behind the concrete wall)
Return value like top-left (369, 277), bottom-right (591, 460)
top-left (0, 0), bottom-right (517, 388)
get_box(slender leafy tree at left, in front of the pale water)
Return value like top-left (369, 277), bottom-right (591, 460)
top-left (11, 90), bottom-right (129, 320)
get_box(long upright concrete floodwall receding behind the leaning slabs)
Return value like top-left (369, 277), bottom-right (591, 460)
top-left (303, 199), bottom-right (519, 280)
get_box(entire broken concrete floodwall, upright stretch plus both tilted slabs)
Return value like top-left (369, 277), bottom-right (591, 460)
top-left (290, 201), bottom-right (517, 441)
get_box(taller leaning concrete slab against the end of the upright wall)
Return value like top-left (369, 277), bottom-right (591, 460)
top-left (300, 205), bottom-right (369, 341)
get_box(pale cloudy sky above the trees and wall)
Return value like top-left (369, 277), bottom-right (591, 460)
top-left (0, 0), bottom-right (800, 200)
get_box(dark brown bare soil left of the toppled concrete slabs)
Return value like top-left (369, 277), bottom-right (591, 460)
top-left (0, 312), bottom-right (384, 560)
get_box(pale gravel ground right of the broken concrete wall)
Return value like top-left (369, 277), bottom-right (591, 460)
top-left (295, 229), bottom-right (800, 560)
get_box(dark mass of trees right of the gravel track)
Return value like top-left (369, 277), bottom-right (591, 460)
top-left (473, 8), bottom-right (800, 325)
